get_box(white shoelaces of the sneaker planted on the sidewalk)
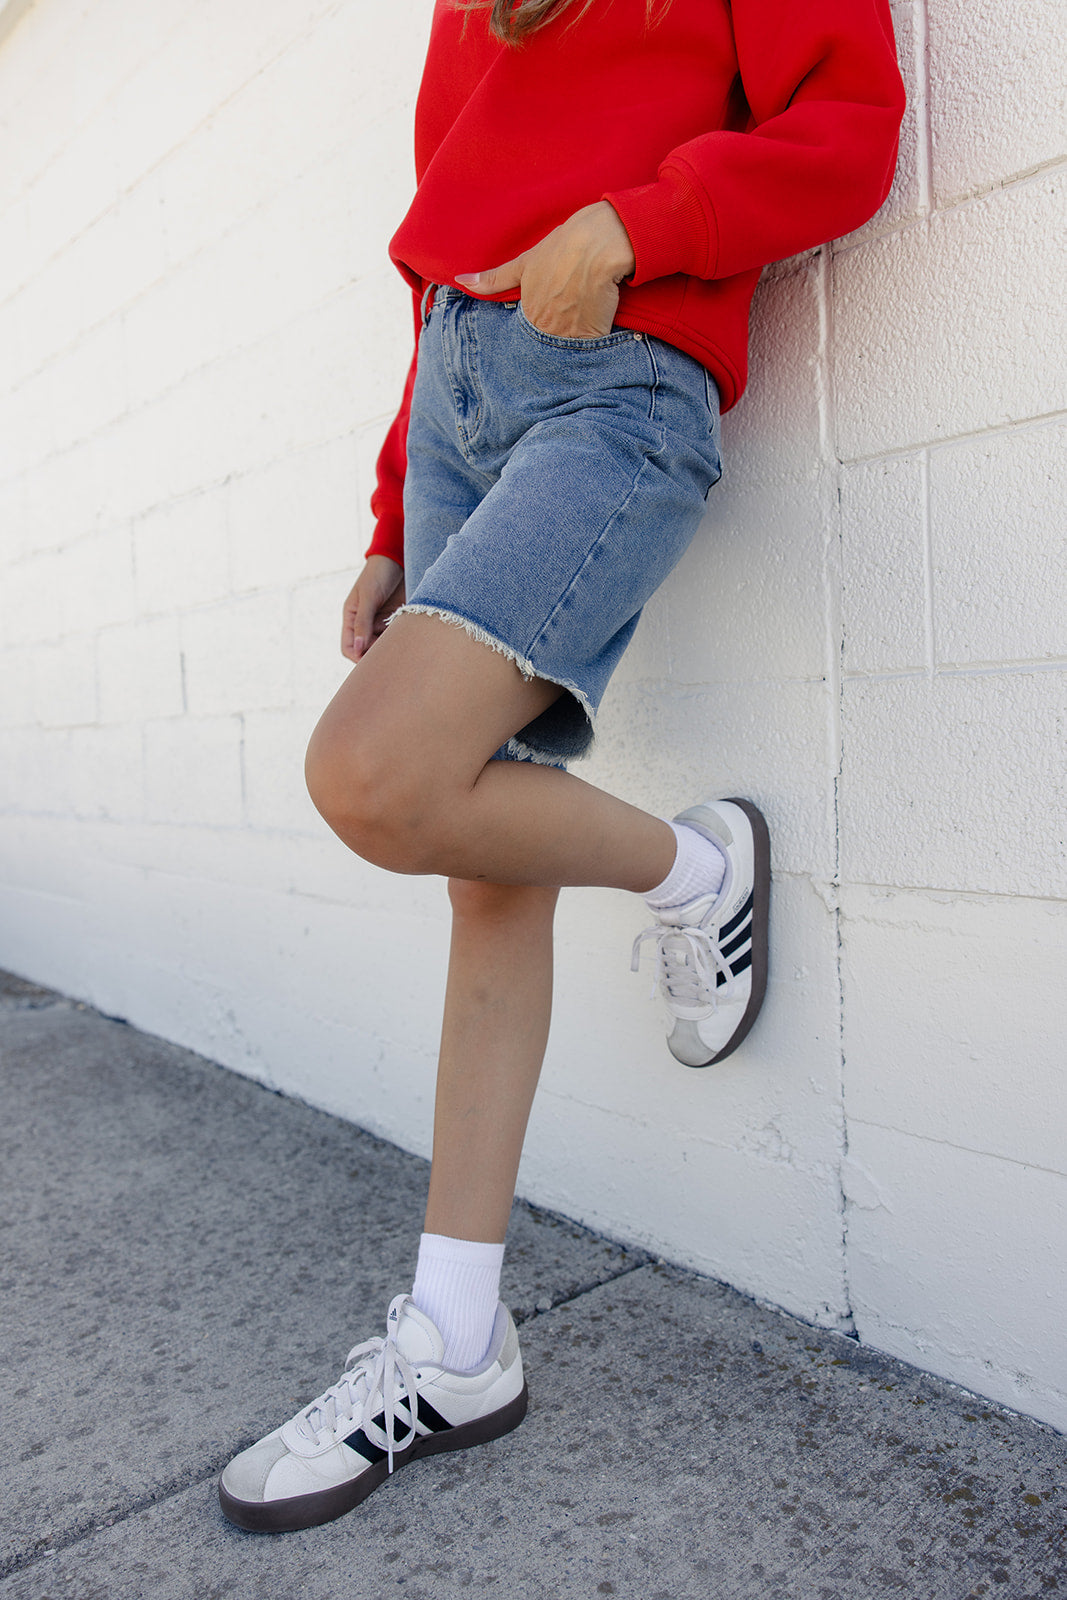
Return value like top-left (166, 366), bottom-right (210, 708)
top-left (293, 1294), bottom-right (419, 1472)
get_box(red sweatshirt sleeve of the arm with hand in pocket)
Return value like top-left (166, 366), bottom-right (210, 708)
top-left (603, 0), bottom-right (904, 285)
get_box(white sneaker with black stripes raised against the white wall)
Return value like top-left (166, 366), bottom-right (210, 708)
top-left (632, 800), bottom-right (771, 1067)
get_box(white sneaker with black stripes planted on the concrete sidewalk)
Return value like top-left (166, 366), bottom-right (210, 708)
top-left (219, 1294), bottom-right (528, 1533)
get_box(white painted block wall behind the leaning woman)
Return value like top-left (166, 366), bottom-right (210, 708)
top-left (0, 0), bottom-right (1067, 1427)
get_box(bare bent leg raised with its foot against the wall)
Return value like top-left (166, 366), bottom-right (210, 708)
top-left (307, 614), bottom-right (675, 893)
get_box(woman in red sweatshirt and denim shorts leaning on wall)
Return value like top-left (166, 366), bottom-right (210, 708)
top-left (221, 0), bottom-right (902, 1530)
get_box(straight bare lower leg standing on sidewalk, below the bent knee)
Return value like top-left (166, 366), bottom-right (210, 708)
top-left (426, 880), bottom-right (557, 1243)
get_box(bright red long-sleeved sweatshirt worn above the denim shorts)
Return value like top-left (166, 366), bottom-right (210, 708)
top-left (368, 0), bottom-right (904, 562)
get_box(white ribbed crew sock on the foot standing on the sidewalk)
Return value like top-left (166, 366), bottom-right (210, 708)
top-left (411, 1234), bottom-right (504, 1373)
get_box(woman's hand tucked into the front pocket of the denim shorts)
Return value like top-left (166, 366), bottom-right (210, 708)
top-left (456, 200), bottom-right (635, 339)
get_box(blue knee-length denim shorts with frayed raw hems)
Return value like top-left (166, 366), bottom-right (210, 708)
top-left (403, 285), bottom-right (721, 765)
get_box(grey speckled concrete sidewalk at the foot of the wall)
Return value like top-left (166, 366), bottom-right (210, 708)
top-left (0, 960), bottom-right (1067, 1600)
